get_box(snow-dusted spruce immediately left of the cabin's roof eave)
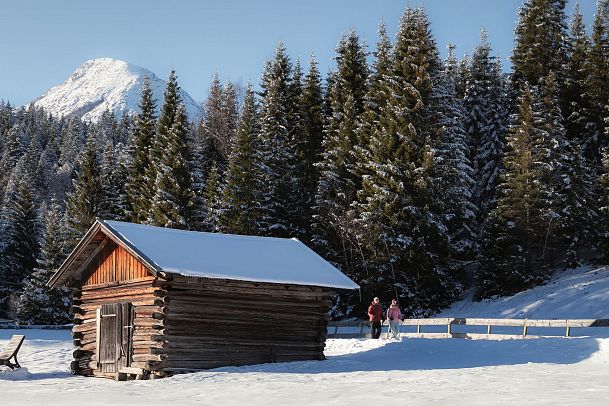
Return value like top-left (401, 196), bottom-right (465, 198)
top-left (17, 200), bottom-right (71, 324)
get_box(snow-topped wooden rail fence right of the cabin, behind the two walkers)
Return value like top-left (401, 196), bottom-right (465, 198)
top-left (328, 317), bottom-right (609, 340)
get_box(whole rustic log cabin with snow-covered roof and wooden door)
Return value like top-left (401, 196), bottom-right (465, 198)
top-left (48, 220), bottom-right (359, 379)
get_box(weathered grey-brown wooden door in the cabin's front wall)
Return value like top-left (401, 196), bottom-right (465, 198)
top-left (97, 303), bottom-right (133, 372)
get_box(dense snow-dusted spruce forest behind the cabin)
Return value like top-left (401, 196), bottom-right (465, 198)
top-left (0, 0), bottom-right (609, 324)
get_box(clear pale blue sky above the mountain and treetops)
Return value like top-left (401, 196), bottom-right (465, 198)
top-left (0, 0), bottom-right (594, 105)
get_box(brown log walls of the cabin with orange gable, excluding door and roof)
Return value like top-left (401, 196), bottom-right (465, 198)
top-left (72, 252), bottom-right (331, 377)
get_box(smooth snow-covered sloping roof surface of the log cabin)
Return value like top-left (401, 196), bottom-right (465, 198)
top-left (100, 220), bottom-right (359, 289)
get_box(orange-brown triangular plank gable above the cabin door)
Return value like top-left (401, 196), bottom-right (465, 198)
top-left (81, 241), bottom-right (152, 286)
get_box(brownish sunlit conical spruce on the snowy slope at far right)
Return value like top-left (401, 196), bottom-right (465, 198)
top-left (478, 82), bottom-right (556, 297)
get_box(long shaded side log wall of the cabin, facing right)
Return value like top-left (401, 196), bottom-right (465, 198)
top-left (153, 276), bottom-right (331, 374)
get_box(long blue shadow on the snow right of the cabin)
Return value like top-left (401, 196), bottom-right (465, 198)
top-left (188, 338), bottom-right (599, 374)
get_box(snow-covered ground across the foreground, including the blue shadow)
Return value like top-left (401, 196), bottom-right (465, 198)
top-left (0, 330), bottom-right (609, 406)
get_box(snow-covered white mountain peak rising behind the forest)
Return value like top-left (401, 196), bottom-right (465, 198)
top-left (34, 58), bottom-right (201, 122)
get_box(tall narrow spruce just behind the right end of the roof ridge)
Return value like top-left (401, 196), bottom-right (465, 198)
top-left (260, 43), bottom-right (299, 237)
